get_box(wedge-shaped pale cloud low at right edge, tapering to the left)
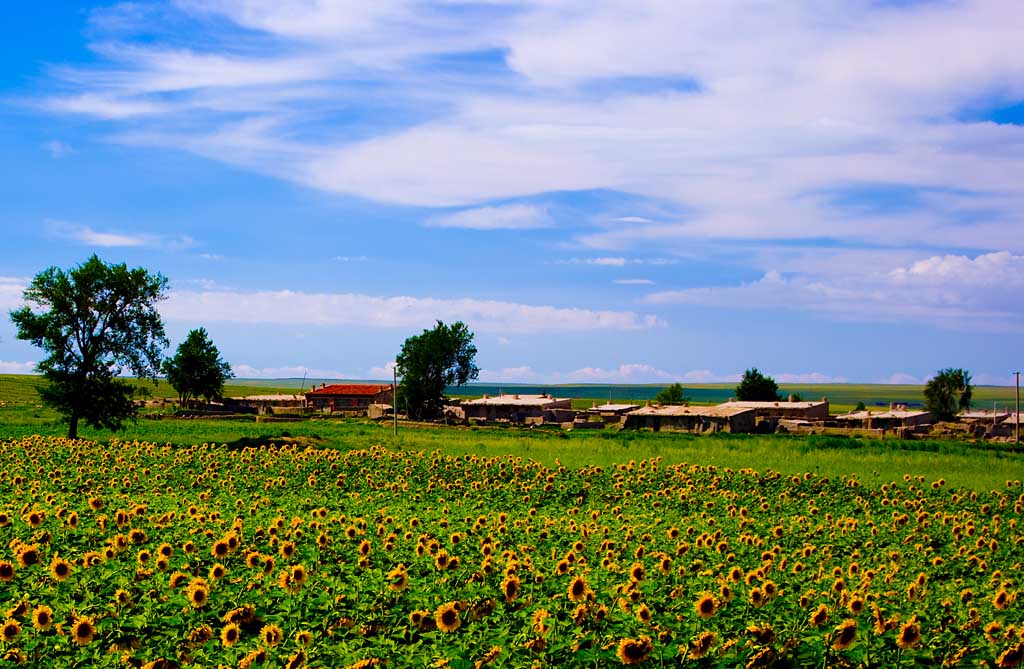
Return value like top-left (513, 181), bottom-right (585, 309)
top-left (644, 251), bottom-right (1024, 331)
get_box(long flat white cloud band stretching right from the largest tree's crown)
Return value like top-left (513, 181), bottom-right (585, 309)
top-left (161, 290), bottom-right (664, 333)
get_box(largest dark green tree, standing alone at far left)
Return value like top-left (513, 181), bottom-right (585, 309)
top-left (10, 255), bottom-right (168, 438)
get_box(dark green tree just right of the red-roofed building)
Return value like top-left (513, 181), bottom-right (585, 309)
top-left (395, 321), bottom-right (480, 419)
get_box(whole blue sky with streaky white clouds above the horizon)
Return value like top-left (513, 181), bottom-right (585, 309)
top-left (0, 0), bottom-right (1024, 384)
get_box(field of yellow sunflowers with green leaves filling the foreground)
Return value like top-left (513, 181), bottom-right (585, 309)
top-left (0, 436), bottom-right (1024, 669)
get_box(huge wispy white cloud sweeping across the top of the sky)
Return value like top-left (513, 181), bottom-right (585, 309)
top-left (25, 0), bottom-right (1024, 258)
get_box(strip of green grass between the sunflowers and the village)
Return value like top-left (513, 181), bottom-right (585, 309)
top-left (0, 376), bottom-right (1024, 490)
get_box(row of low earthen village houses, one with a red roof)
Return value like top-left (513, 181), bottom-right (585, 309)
top-left (172, 383), bottom-right (1020, 442)
